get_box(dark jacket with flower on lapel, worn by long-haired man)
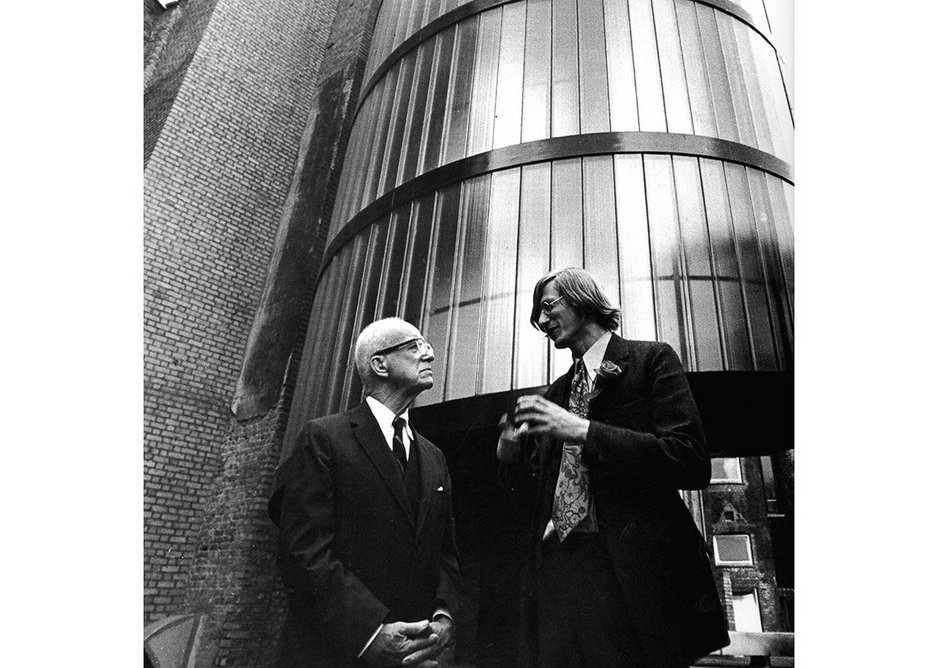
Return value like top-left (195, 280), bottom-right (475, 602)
top-left (522, 334), bottom-right (729, 666)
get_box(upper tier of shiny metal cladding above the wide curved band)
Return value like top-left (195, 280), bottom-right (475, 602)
top-left (332, 0), bottom-right (792, 235)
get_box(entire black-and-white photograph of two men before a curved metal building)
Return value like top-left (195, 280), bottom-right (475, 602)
top-left (144, 0), bottom-right (795, 668)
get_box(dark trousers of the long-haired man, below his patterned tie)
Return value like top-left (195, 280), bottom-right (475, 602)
top-left (536, 532), bottom-right (646, 668)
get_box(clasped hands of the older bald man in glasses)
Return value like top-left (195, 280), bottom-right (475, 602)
top-left (362, 615), bottom-right (453, 668)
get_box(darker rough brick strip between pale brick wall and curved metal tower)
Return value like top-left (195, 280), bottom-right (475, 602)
top-left (179, 0), bottom-right (388, 666)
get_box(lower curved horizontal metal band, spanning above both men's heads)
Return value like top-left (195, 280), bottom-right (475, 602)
top-left (319, 132), bottom-right (794, 277)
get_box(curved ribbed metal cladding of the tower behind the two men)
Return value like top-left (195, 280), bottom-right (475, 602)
top-left (291, 0), bottom-right (794, 438)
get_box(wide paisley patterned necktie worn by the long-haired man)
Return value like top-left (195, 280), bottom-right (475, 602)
top-left (551, 360), bottom-right (589, 542)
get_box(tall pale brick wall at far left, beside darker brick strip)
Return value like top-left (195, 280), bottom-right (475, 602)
top-left (144, 0), bottom-right (334, 640)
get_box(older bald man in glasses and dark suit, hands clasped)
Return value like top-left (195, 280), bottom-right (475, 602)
top-left (269, 318), bottom-right (459, 667)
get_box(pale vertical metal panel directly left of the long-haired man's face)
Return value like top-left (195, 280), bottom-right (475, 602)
top-left (513, 162), bottom-right (551, 388)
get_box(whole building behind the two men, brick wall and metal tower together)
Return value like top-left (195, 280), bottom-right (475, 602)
top-left (145, 0), bottom-right (794, 665)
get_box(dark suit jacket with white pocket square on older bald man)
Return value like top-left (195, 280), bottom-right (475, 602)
top-left (269, 403), bottom-right (459, 666)
